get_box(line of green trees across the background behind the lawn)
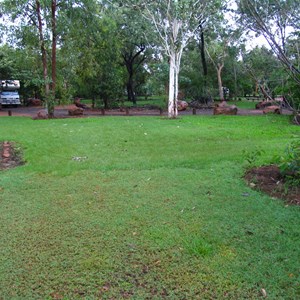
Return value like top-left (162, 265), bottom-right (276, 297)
top-left (0, 0), bottom-right (300, 116)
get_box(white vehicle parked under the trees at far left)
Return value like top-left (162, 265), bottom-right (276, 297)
top-left (0, 80), bottom-right (21, 105)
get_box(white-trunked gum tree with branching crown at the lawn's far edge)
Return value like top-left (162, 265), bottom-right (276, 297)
top-left (128, 0), bottom-right (218, 118)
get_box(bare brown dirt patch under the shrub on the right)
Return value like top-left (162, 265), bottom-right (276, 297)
top-left (245, 165), bottom-right (300, 205)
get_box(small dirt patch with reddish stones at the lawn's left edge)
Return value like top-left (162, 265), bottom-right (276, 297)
top-left (0, 141), bottom-right (24, 170)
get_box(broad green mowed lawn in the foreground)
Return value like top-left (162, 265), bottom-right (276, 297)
top-left (0, 116), bottom-right (300, 299)
